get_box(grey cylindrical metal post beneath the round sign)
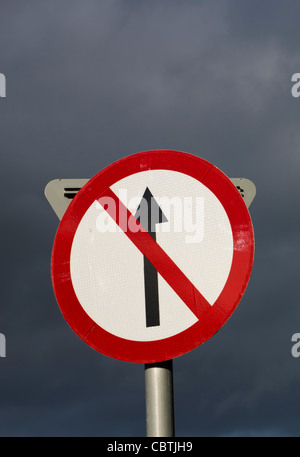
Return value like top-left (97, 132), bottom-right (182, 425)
top-left (145, 360), bottom-right (175, 437)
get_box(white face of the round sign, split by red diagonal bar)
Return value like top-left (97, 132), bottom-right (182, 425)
top-left (70, 169), bottom-right (233, 341)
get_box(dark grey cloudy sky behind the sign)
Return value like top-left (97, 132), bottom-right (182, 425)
top-left (0, 0), bottom-right (300, 436)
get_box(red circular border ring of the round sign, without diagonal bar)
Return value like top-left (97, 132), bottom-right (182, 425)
top-left (51, 150), bottom-right (254, 363)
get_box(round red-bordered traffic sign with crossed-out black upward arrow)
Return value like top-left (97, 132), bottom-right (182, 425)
top-left (51, 150), bottom-right (254, 363)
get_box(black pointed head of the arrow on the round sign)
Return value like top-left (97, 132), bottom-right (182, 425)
top-left (135, 187), bottom-right (168, 233)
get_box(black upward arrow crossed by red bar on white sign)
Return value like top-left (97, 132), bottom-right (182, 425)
top-left (135, 187), bottom-right (168, 327)
